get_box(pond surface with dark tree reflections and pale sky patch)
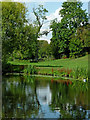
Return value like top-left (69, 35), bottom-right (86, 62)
top-left (2, 76), bottom-right (90, 119)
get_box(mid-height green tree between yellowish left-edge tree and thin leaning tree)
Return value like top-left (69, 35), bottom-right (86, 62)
top-left (12, 24), bottom-right (37, 59)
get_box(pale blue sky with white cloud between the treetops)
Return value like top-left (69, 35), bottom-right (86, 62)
top-left (25, 2), bottom-right (88, 43)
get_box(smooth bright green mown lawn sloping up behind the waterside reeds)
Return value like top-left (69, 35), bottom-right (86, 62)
top-left (8, 55), bottom-right (89, 69)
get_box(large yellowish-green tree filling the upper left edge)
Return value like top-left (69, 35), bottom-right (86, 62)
top-left (1, 2), bottom-right (27, 71)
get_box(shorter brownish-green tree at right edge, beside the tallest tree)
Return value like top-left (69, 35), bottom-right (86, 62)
top-left (69, 24), bottom-right (90, 57)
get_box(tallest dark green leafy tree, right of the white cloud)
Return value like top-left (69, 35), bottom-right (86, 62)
top-left (51, 1), bottom-right (88, 58)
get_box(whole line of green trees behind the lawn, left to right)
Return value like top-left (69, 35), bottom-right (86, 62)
top-left (2, 1), bottom-right (90, 70)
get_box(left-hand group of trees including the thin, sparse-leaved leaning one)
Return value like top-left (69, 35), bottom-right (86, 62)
top-left (1, 2), bottom-right (48, 69)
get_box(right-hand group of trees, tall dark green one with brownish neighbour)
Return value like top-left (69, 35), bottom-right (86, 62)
top-left (50, 1), bottom-right (90, 58)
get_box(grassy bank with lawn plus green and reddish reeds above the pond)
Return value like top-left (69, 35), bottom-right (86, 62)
top-left (9, 55), bottom-right (88, 79)
